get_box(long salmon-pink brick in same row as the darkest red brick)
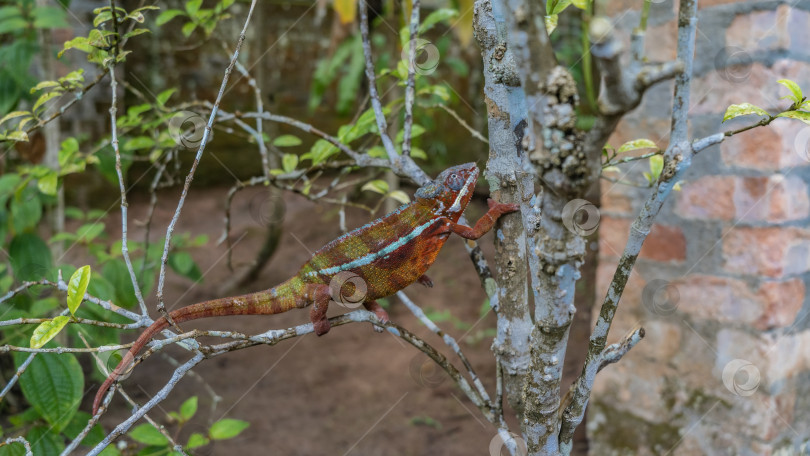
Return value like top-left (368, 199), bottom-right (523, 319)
top-left (722, 227), bottom-right (810, 277)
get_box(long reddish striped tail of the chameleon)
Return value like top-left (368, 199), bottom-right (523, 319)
top-left (93, 279), bottom-right (297, 415)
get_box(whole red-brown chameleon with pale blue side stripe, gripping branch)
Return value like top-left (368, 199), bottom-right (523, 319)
top-left (93, 163), bottom-right (518, 415)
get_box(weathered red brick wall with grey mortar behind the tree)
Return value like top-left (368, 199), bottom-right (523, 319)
top-left (588, 0), bottom-right (810, 455)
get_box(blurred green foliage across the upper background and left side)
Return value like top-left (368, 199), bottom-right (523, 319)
top-left (0, 0), bottom-right (596, 456)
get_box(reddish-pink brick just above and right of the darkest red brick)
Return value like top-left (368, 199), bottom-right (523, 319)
top-left (675, 176), bottom-right (735, 220)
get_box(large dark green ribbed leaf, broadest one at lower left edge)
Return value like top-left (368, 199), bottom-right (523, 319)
top-left (14, 352), bottom-right (84, 432)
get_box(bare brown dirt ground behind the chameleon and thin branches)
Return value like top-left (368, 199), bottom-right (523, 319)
top-left (87, 188), bottom-right (588, 456)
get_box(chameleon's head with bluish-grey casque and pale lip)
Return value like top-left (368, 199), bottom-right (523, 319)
top-left (414, 163), bottom-right (478, 216)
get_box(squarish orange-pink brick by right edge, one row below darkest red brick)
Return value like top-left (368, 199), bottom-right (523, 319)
top-left (754, 279), bottom-right (805, 330)
